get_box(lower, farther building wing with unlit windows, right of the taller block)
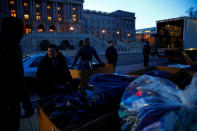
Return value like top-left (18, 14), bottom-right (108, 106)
top-left (84, 10), bottom-right (135, 41)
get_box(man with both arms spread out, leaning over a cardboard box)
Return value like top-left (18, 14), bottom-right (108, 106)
top-left (72, 38), bottom-right (103, 70)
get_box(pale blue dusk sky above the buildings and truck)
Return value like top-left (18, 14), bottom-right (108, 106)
top-left (84, 0), bottom-right (197, 29)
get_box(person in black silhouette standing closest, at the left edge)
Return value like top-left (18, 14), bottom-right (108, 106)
top-left (0, 17), bottom-right (34, 131)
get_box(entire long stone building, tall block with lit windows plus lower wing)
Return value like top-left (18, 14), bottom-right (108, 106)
top-left (0, 0), bottom-right (135, 50)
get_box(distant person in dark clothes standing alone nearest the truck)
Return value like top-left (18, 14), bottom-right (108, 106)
top-left (143, 41), bottom-right (151, 66)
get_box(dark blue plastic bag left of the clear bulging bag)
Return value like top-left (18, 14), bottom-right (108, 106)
top-left (86, 74), bottom-right (136, 111)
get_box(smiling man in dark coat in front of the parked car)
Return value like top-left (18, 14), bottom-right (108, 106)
top-left (36, 44), bottom-right (72, 97)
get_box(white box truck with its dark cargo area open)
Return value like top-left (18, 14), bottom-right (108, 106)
top-left (154, 17), bottom-right (197, 64)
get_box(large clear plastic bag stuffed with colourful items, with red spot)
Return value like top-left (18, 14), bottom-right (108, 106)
top-left (119, 74), bottom-right (197, 131)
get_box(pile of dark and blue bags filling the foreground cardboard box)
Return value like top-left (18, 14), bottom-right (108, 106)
top-left (39, 74), bottom-right (135, 129)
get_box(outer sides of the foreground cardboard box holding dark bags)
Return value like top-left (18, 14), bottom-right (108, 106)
top-left (37, 106), bottom-right (120, 131)
